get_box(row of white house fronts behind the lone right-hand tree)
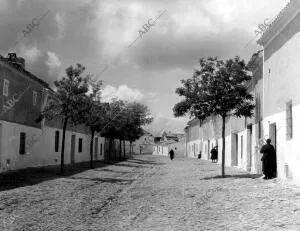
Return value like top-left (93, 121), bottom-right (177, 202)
top-left (185, 51), bottom-right (263, 173)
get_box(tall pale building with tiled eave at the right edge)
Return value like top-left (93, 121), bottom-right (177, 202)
top-left (258, 0), bottom-right (300, 180)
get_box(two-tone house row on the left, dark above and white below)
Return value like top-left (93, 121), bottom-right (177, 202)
top-left (0, 53), bottom-right (129, 173)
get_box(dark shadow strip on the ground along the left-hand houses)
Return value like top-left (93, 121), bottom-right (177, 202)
top-left (0, 161), bottom-right (125, 192)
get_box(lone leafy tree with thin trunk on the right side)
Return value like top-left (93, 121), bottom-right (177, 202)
top-left (173, 57), bottom-right (254, 177)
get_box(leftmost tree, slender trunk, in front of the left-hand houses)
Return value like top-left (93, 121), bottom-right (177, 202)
top-left (42, 64), bottom-right (89, 174)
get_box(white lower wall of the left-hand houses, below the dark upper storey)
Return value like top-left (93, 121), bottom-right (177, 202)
top-left (0, 121), bottom-right (104, 172)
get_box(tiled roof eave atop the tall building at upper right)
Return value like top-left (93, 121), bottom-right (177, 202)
top-left (257, 0), bottom-right (300, 47)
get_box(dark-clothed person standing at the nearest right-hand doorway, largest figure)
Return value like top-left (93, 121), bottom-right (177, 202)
top-left (260, 139), bottom-right (276, 179)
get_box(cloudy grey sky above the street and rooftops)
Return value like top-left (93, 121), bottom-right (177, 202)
top-left (0, 0), bottom-right (289, 132)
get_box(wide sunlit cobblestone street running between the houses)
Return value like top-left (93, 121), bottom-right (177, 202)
top-left (0, 155), bottom-right (300, 231)
